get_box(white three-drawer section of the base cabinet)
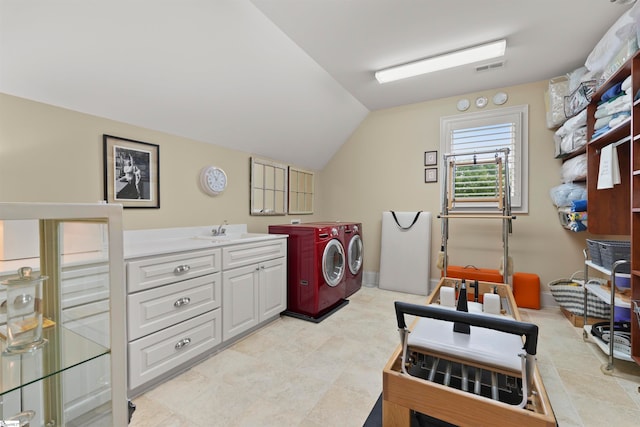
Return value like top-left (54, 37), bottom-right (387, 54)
top-left (127, 248), bottom-right (222, 393)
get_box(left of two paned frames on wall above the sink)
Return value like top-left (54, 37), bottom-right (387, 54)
top-left (250, 157), bottom-right (288, 215)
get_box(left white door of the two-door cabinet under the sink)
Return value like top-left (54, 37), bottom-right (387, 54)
top-left (222, 264), bottom-right (260, 341)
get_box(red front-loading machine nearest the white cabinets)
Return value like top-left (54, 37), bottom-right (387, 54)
top-left (269, 224), bottom-right (348, 322)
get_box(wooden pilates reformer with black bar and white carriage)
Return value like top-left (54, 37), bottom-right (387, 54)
top-left (383, 278), bottom-right (556, 427)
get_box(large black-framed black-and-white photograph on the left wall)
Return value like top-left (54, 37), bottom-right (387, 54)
top-left (102, 135), bottom-right (160, 209)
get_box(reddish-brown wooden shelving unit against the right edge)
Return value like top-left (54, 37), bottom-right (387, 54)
top-left (587, 53), bottom-right (640, 364)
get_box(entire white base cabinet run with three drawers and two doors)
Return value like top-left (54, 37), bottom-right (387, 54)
top-left (125, 229), bottom-right (287, 396)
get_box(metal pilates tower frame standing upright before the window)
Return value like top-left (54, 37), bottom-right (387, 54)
top-left (438, 148), bottom-right (516, 284)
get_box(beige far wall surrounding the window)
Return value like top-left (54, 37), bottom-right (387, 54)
top-left (318, 82), bottom-right (587, 292)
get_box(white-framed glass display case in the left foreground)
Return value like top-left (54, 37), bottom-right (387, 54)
top-left (0, 203), bottom-right (128, 427)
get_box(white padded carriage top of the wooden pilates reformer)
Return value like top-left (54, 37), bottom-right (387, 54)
top-left (407, 317), bottom-right (525, 372)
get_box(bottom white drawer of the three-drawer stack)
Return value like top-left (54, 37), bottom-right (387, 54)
top-left (128, 309), bottom-right (222, 390)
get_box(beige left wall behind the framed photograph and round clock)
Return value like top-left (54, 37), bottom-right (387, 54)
top-left (0, 94), bottom-right (315, 232)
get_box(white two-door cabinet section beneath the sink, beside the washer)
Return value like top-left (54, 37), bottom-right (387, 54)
top-left (222, 240), bottom-right (287, 341)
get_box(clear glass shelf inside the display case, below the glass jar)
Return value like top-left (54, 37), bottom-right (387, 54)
top-left (0, 325), bottom-right (110, 396)
